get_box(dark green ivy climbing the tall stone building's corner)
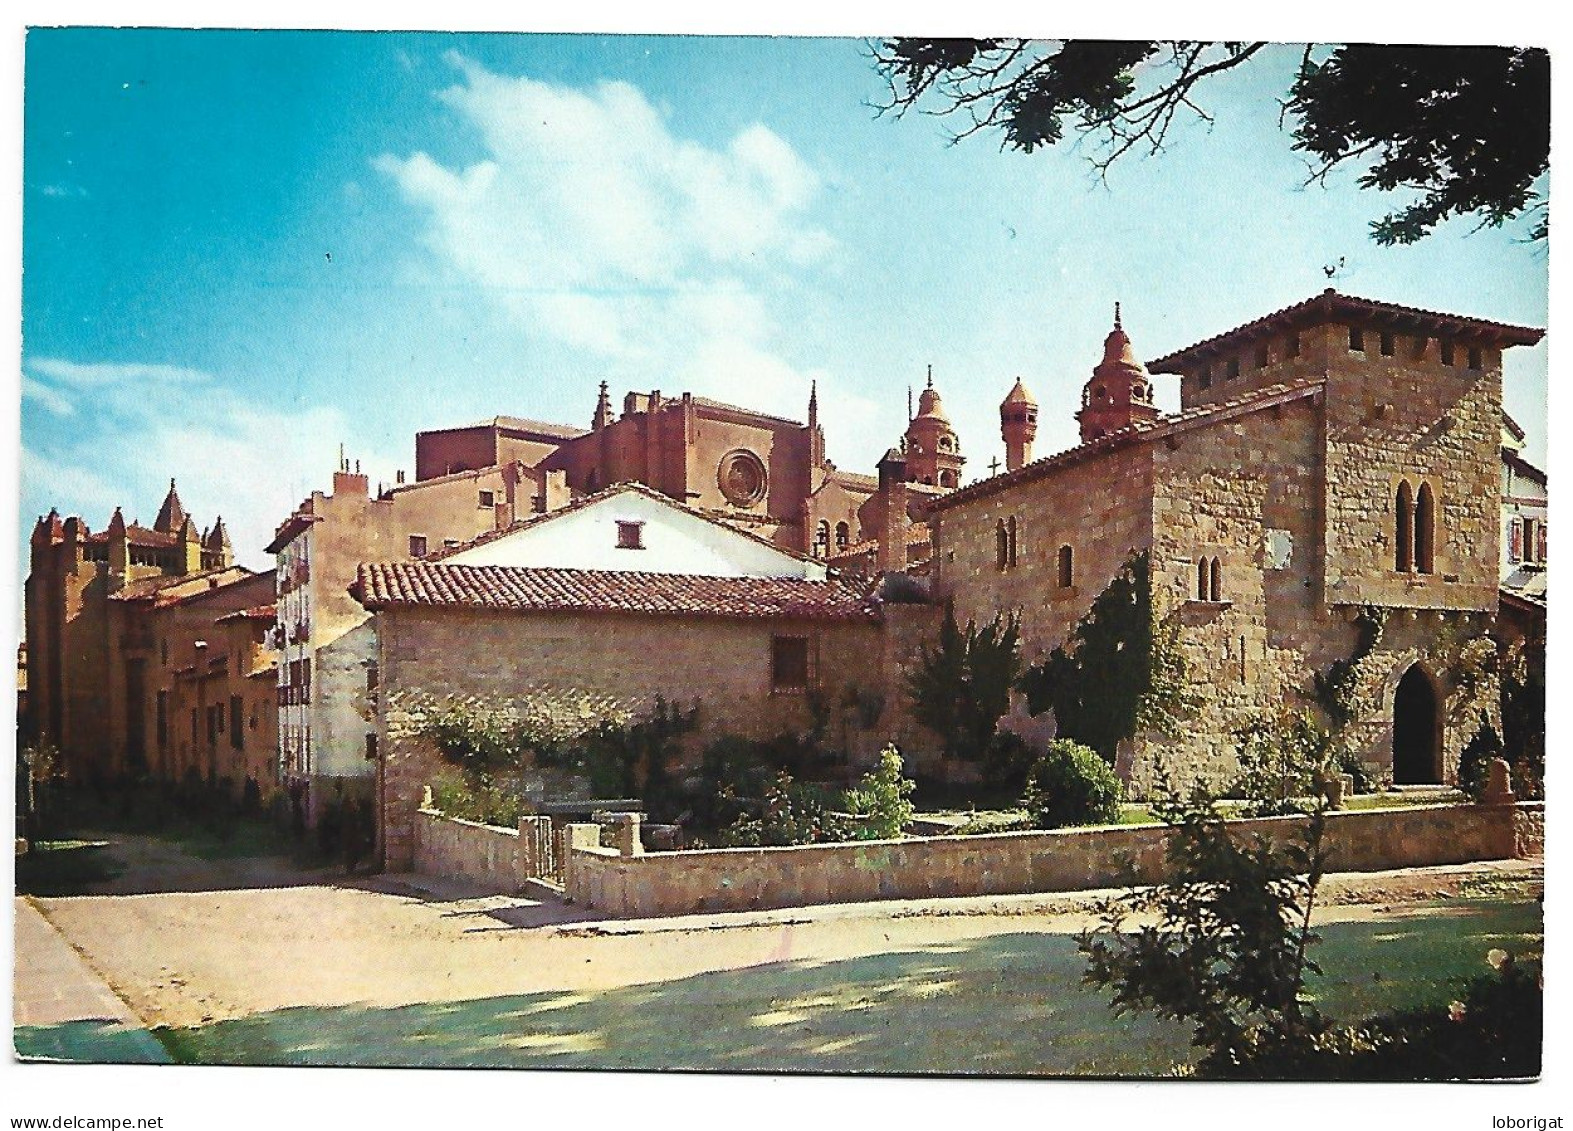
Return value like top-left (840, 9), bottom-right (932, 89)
top-left (1019, 551), bottom-right (1194, 761)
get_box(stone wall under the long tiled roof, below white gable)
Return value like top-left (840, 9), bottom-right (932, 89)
top-left (378, 609), bottom-right (881, 870)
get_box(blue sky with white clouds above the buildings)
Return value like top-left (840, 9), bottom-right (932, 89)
top-left (22, 30), bottom-right (1546, 566)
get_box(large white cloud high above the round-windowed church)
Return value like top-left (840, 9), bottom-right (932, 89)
top-left (373, 53), bottom-right (835, 417)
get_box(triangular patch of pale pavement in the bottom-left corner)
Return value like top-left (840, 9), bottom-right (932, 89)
top-left (11, 897), bottom-right (170, 1063)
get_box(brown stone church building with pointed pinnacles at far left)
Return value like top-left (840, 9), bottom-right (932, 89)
top-left (24, 480), bottom-right (255, 779)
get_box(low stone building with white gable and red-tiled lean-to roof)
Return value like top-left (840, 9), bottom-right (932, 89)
top-left (352, 484), bottom-right (934, 868)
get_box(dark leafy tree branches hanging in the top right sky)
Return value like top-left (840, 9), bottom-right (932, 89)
top-left (871, 38), bottom-right (1551, 245)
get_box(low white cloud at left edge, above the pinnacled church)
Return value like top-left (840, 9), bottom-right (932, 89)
top-left (22, 357), bottom-right (393, 568)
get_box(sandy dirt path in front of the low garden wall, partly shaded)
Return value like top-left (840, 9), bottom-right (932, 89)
top-left (36, 846), bottom-right (1538, 1071)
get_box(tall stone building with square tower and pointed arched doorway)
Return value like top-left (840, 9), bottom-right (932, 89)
top-left (928, 289), bottom-right (1543, 793)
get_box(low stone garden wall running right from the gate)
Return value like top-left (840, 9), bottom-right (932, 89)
top-left (565, 805), bottom-right (1542, 917)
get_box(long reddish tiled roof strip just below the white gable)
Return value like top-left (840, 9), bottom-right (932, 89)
top-left (349, 562), bottom-right (878, 620)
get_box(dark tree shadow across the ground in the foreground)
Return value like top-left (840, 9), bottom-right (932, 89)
top-left (141, 900), bottom-right (1542, 1076)
